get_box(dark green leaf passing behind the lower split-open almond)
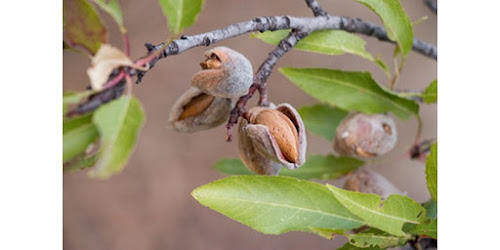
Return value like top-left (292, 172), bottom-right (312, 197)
top-left (215, 155), bottom-right (364, 180)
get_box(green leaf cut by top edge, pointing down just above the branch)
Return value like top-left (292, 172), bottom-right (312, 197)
top-left (158, 0), bottom-right (204, 35)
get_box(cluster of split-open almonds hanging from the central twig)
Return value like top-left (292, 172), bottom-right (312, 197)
top-left (169, 47), bottom-right (306, 175)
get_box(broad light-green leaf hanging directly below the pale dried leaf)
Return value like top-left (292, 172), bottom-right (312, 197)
top-left (89, 96), bottom-right (144, 178)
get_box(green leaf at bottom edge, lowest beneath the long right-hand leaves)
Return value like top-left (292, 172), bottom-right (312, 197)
top-left (311, 228), bottom-right (410, 249)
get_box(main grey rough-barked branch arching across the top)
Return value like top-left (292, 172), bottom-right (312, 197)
top-left (68, 9), bottom-right (437, 114)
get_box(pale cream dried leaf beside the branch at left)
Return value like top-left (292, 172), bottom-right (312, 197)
top-left (87, 44), bottom-right (147, 90)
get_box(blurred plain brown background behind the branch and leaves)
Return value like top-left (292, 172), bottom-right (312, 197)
top-left (63, 0), bottom-right (437, 250)
